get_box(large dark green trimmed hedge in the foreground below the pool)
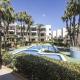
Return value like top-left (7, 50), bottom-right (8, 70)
top-left (14, 54), bottom-right (80, 80)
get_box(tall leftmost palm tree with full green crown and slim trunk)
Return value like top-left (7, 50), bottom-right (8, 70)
top-left (3, 6), bottom-right (15, 50)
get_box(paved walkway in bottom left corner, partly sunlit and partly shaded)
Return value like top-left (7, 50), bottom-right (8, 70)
top-left (0, 66), bottom-right (27, 80)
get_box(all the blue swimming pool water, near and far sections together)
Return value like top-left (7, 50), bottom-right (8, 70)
top-left (20, 45), bottom-right (62, 60)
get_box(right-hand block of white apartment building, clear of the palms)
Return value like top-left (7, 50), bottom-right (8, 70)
top-left (28, 24), bottom-right (51, 42)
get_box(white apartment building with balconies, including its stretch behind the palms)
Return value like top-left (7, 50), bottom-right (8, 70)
top-left (9, 23), bottom-right (51, 42)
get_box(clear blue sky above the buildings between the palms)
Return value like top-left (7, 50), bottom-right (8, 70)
top-left (12, 0), bottom-right (66, 30)
